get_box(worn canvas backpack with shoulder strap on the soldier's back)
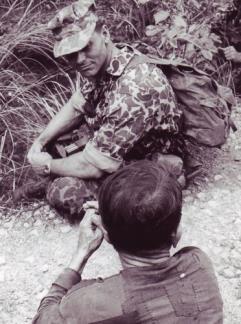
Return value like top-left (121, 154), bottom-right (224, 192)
top-left (129, 55), bottom-right (237, 147)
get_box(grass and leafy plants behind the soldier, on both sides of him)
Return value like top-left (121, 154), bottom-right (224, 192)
top-left (0, 0), bottom-right (237, 206)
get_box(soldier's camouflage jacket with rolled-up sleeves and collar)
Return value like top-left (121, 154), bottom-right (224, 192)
top-left (71, 45), bottom-right (182, 172)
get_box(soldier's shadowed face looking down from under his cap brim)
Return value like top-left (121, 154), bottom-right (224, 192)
top-left (67, 32), bottom-right (108, 77)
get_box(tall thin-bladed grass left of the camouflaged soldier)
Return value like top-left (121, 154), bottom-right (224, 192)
top-left (0, 0), bottom-right (74, 205)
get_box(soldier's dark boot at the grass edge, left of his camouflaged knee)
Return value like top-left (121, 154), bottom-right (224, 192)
top-left (12, 177), bottom-right (50, 203)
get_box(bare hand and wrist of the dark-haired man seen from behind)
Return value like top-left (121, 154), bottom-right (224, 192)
top-left (69, 207), bottom-right (104, 272)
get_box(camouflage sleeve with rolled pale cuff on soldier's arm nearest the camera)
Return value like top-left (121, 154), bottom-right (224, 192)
top-left (82, 64), bottom-right (180, 165)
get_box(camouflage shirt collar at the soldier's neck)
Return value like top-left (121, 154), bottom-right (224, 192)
top-left (106, 44), bottom-right (137, 76)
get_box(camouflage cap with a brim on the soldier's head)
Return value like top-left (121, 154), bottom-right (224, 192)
top-left (48, 0), bottom-right (98, 57)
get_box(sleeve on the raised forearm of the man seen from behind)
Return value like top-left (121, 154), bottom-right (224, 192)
top-left (32, 268), bottom-right (81, 324)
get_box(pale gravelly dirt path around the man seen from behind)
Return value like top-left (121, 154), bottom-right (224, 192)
top-left (0, 107), bottom-right (241, 324)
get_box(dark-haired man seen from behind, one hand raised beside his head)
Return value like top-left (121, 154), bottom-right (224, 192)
top-left (33, 161), bottom-right (223, 324)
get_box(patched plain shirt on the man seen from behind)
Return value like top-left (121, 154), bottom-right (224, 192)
top-left (33, 247), bottom-right (223, 324)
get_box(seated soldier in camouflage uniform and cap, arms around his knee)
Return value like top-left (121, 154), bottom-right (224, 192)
top-left (14, 0), bottom-right (185, 218)
